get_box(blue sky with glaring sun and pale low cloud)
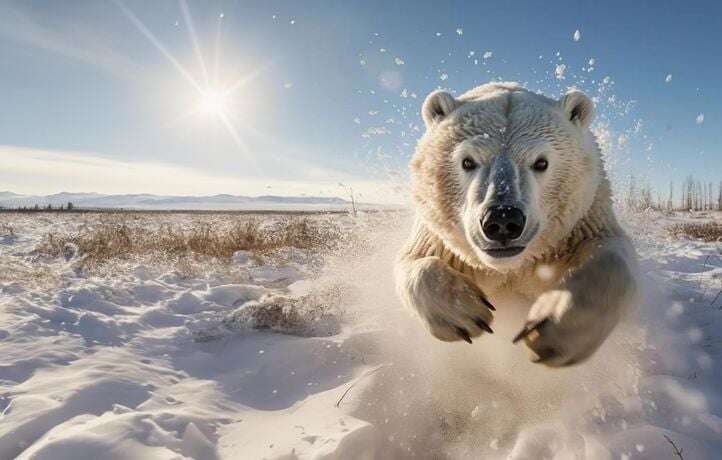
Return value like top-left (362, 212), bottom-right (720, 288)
top-left (0, 0), bottom-right (722, 201)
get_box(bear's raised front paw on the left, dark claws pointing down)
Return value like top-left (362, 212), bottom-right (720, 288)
top-left (407, 257), bottom-right (494, 343)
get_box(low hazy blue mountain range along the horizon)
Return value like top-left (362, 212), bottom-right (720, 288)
top-left (0, 192), bottom-right (360, 210)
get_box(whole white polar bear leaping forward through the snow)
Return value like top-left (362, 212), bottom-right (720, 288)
top-left (395, 82), bottom-right (638, 367)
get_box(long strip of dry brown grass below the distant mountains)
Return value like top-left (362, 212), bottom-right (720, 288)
top-left (36, 218), bottom-right (340, 267)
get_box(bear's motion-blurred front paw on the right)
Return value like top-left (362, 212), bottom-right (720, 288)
top-left (514, 290), bottom-right (611, 367)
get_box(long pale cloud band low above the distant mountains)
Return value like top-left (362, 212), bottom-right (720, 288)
top-left (0, 146), bottom-right (404, 203)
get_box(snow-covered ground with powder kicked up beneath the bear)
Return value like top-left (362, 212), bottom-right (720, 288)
top-left (0, 210), bottom-right (722, 460)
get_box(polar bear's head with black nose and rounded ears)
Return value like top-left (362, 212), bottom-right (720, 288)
top-left (411, 83), bottom-right (604, 271)
